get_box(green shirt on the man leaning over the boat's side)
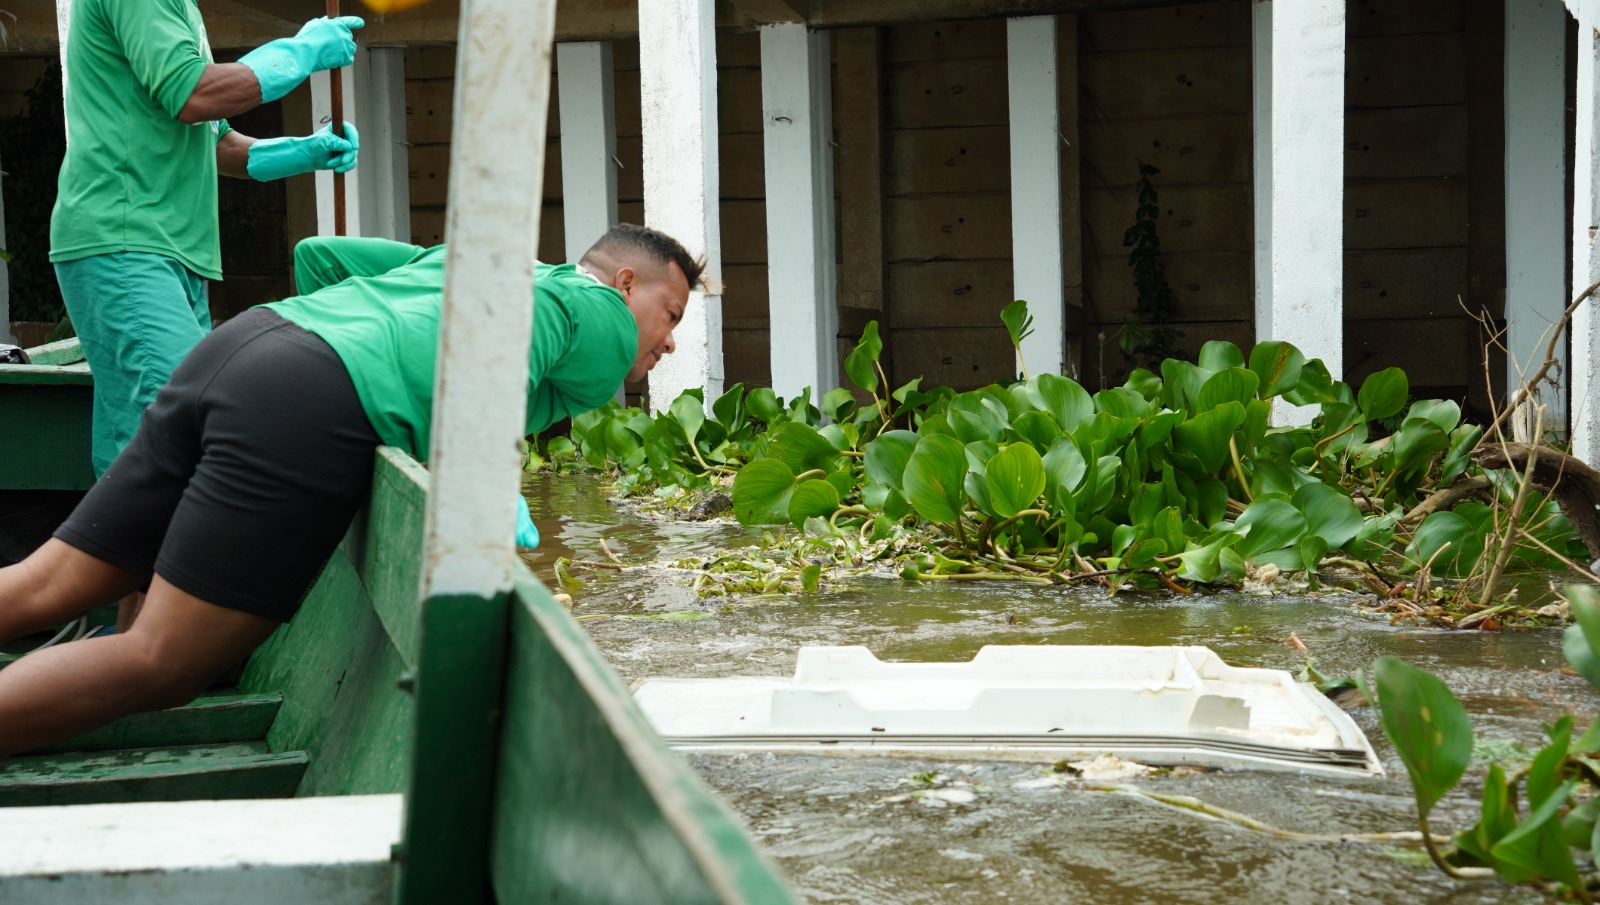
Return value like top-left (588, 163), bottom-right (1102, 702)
top-left (266, 238), bottom-right (638, 459)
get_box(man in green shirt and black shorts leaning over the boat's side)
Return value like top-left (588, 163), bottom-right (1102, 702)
top-left (0, 225), bottom-right (702, 758)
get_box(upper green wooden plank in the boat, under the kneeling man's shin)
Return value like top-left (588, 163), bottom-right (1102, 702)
top-left (32, 694), bottom-right (283, 755)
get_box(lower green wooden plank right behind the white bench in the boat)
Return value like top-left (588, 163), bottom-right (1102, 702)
top-left (0, 742), bottom-right (307, 807)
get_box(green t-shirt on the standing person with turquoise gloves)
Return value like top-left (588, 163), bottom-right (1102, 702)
top-left (50, 0), bottom-right (227, 280)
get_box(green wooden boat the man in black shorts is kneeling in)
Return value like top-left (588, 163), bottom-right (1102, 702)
top-left (0, 341), bottom-right (790, 903)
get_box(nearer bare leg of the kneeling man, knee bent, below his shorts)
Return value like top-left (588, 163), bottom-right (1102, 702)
top-left (0, 576), bottom-right (278, 758)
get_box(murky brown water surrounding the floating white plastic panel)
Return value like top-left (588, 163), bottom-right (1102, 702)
top-left (528, 476), bottom-right (1574, 905)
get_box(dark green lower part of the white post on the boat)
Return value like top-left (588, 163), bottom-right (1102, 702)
top-left (395, 595), bottom-right (505, 905)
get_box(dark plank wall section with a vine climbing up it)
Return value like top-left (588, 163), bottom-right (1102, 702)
top-left (1062, 2), bottom-right (1254, 390)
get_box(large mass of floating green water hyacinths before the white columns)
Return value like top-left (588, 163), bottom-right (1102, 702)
top-left (533, 302), bottom-right (1590, 628)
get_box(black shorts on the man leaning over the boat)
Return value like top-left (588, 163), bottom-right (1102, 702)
top-left (56, 309), bottom-right (381, 622)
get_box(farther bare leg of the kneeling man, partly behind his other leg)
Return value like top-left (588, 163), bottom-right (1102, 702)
top-left (0, 537), bottom-right (139, 641)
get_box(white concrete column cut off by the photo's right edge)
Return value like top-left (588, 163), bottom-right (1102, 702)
top-left (1568, 12), bottom-right (1600, 467)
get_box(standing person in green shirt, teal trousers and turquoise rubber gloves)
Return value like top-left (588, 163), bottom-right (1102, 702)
top-left (50, 0), bottom-right (362, 475)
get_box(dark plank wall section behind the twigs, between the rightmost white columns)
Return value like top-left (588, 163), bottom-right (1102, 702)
top-left (1344, 0), bottom-right (1506, 408)
